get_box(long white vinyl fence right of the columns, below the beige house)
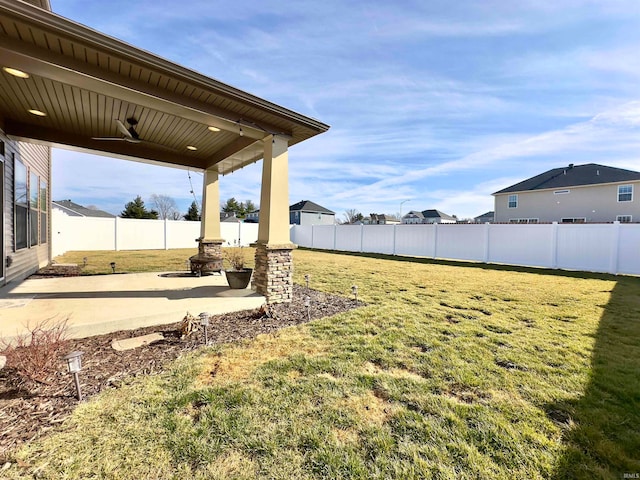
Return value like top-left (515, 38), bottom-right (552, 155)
top-left (291, 222), bottom-right (640, 275)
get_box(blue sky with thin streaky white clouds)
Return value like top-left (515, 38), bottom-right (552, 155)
top-left (51, 0), bottom-right (640, 218)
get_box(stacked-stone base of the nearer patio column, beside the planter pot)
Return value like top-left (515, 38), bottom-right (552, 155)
top-left (252, 243), bottom-right (296, 303)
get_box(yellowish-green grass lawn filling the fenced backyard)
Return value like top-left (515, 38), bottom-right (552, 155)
top-left (8, 250), bottom-right (640, 479)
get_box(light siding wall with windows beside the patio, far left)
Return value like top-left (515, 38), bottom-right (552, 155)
top-left (0, 130), bottom-right (51, 285)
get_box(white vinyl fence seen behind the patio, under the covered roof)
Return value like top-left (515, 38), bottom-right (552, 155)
top-left (51, 209), bottom-right (258, 257)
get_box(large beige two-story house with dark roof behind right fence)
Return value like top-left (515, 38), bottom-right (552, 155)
top-left (493, 163), bottom-right (640, 223)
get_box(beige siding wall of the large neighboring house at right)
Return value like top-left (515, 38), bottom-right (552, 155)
top-left (495, 181), bottom-right (640, 223)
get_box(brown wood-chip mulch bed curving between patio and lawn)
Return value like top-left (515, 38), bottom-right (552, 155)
top-left (0, 284), bottom-right (356, 458)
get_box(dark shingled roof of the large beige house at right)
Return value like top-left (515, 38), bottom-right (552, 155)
top-left (493, 163), bottom-right (640, 195)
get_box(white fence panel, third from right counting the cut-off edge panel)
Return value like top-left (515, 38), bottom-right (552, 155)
top-left (487, 224), bottom-right (555, 267)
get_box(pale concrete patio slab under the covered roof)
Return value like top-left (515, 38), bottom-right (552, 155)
top-left (0, 272), bottom-right (265, 340)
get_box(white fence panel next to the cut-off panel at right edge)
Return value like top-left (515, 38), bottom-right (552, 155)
top-left (556, 224), bottom-right (615, 272)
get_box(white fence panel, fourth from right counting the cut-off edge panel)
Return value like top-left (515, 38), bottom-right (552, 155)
top-left (436, 224), bottom-right (486, 262)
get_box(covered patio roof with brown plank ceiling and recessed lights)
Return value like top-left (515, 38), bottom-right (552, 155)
top-left (0, 0), bottom-right (329, 174)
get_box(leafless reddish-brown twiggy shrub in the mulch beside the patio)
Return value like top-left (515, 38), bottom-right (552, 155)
top-left (0, 318), bottom-right (68, 383)
